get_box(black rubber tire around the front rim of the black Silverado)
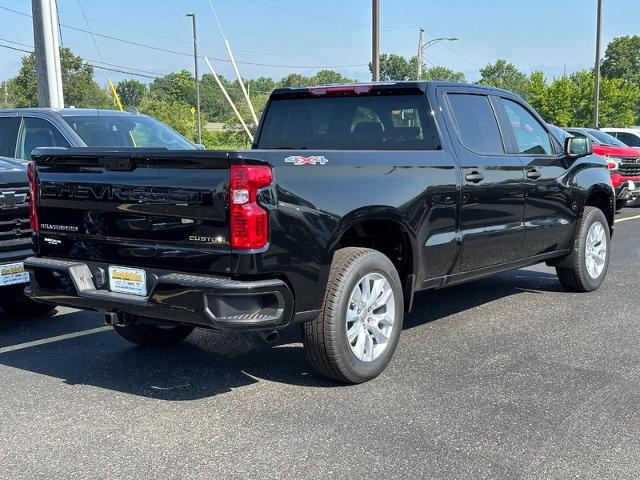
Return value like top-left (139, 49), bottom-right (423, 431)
top-left (556, 207), bottom-right (611, 292)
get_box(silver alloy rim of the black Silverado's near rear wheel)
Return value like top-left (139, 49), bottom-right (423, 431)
top-left (346, 273), bottom-right (396, 362)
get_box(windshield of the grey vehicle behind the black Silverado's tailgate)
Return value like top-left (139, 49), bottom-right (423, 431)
top-left (63, 114), bottom-right (196, 150)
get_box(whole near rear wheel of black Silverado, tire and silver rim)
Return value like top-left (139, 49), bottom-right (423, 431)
top-left (303, 248), bottom-right (404, 383)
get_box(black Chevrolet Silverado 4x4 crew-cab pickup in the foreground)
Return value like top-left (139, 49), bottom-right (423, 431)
top-left (26, 82), bottom-right (615, 383)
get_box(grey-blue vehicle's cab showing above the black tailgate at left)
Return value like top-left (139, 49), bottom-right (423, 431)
top-left (0, 108), bottom-right (197, 160)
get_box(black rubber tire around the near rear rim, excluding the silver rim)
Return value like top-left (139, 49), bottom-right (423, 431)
top-left (303, 247), bottom-right (404, 384)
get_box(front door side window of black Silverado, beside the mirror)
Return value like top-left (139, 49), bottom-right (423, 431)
top-left (502, 98), bottom-right (553, 155)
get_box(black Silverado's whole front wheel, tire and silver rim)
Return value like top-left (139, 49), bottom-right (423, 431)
top-left (556, 207), bottom-right (611, 292)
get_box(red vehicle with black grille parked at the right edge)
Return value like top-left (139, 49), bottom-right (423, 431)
top-left (565, 128), bottom-right (640, 210)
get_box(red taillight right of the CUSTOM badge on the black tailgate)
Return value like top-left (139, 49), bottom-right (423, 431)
top-left (229, 165), bottom-right (273, 250)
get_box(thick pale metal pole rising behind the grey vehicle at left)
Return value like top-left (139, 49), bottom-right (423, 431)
top-left (31, 0), bottom-right (64, 108)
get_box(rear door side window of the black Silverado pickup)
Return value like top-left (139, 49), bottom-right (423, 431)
top-left (447, 93), bottom-right (504, 155)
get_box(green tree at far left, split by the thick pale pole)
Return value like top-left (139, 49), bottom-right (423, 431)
top-left (7, 48), bottom-right (111, 108)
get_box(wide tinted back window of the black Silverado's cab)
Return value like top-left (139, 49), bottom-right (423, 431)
top-left (257, 95), bottom-right (440, 150)
